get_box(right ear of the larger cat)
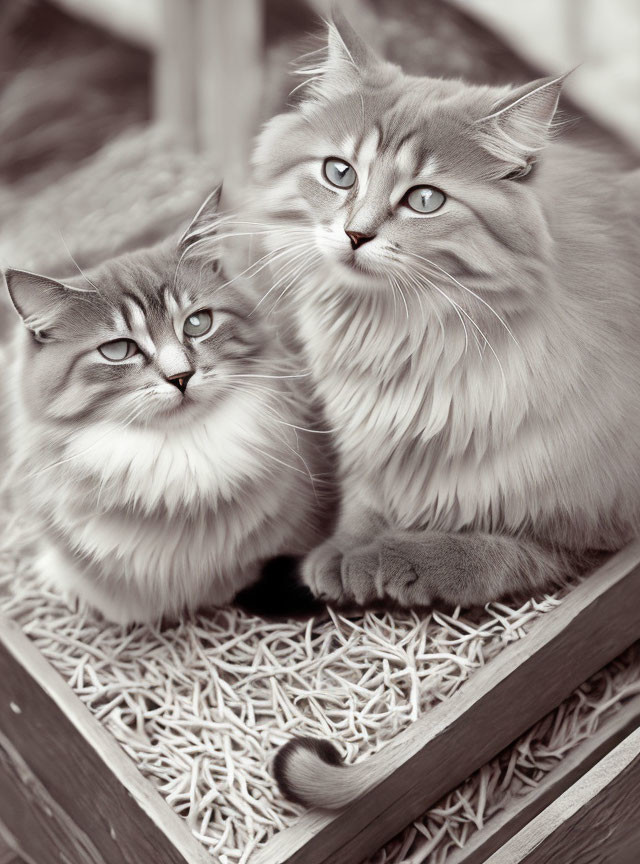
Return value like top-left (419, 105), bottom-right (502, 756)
top-left (477, 73), bottom-right (570, 167)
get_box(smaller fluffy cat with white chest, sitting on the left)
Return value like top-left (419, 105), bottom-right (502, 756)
top-left (1, 189), bottom-right (327, 625)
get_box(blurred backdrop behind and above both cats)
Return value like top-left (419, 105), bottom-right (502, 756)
top-left (0, 0), bottom-right (640, 338)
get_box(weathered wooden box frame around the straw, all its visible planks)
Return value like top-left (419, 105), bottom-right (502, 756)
top-left (0, 542), bottom-right (640, 864)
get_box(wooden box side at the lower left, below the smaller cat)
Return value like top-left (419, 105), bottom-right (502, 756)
top-left (0, 616), bottom-right (213, 864)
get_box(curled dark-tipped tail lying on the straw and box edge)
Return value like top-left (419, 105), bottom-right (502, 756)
top-left (273, 738), bottom-right (378, 810)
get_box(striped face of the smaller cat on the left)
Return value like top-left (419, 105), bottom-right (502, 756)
top-left (7, 192), bottom-right (265, 426)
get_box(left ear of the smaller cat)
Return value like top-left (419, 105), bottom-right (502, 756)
top-left (5, 268), bottom-right (73, 342)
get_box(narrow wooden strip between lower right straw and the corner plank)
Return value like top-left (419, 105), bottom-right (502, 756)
top-left (447, 696), bottom-right (640, 864)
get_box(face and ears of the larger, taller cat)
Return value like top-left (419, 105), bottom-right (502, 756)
top-left (254, 16), bottom-right (559, 310)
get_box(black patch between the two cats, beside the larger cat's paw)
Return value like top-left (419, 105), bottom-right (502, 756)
top-left (234, 555), bottom-right (326, 618)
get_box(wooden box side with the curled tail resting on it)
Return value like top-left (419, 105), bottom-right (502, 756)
top-left (255, 540), bottom-right (640, 864)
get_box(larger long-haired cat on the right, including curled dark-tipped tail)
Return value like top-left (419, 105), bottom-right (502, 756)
top-left (246, 13), bottom-right (640, 807)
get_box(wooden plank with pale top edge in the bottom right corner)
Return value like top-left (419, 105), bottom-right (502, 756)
top-left (487, 729), bottom-right (640, 864)
